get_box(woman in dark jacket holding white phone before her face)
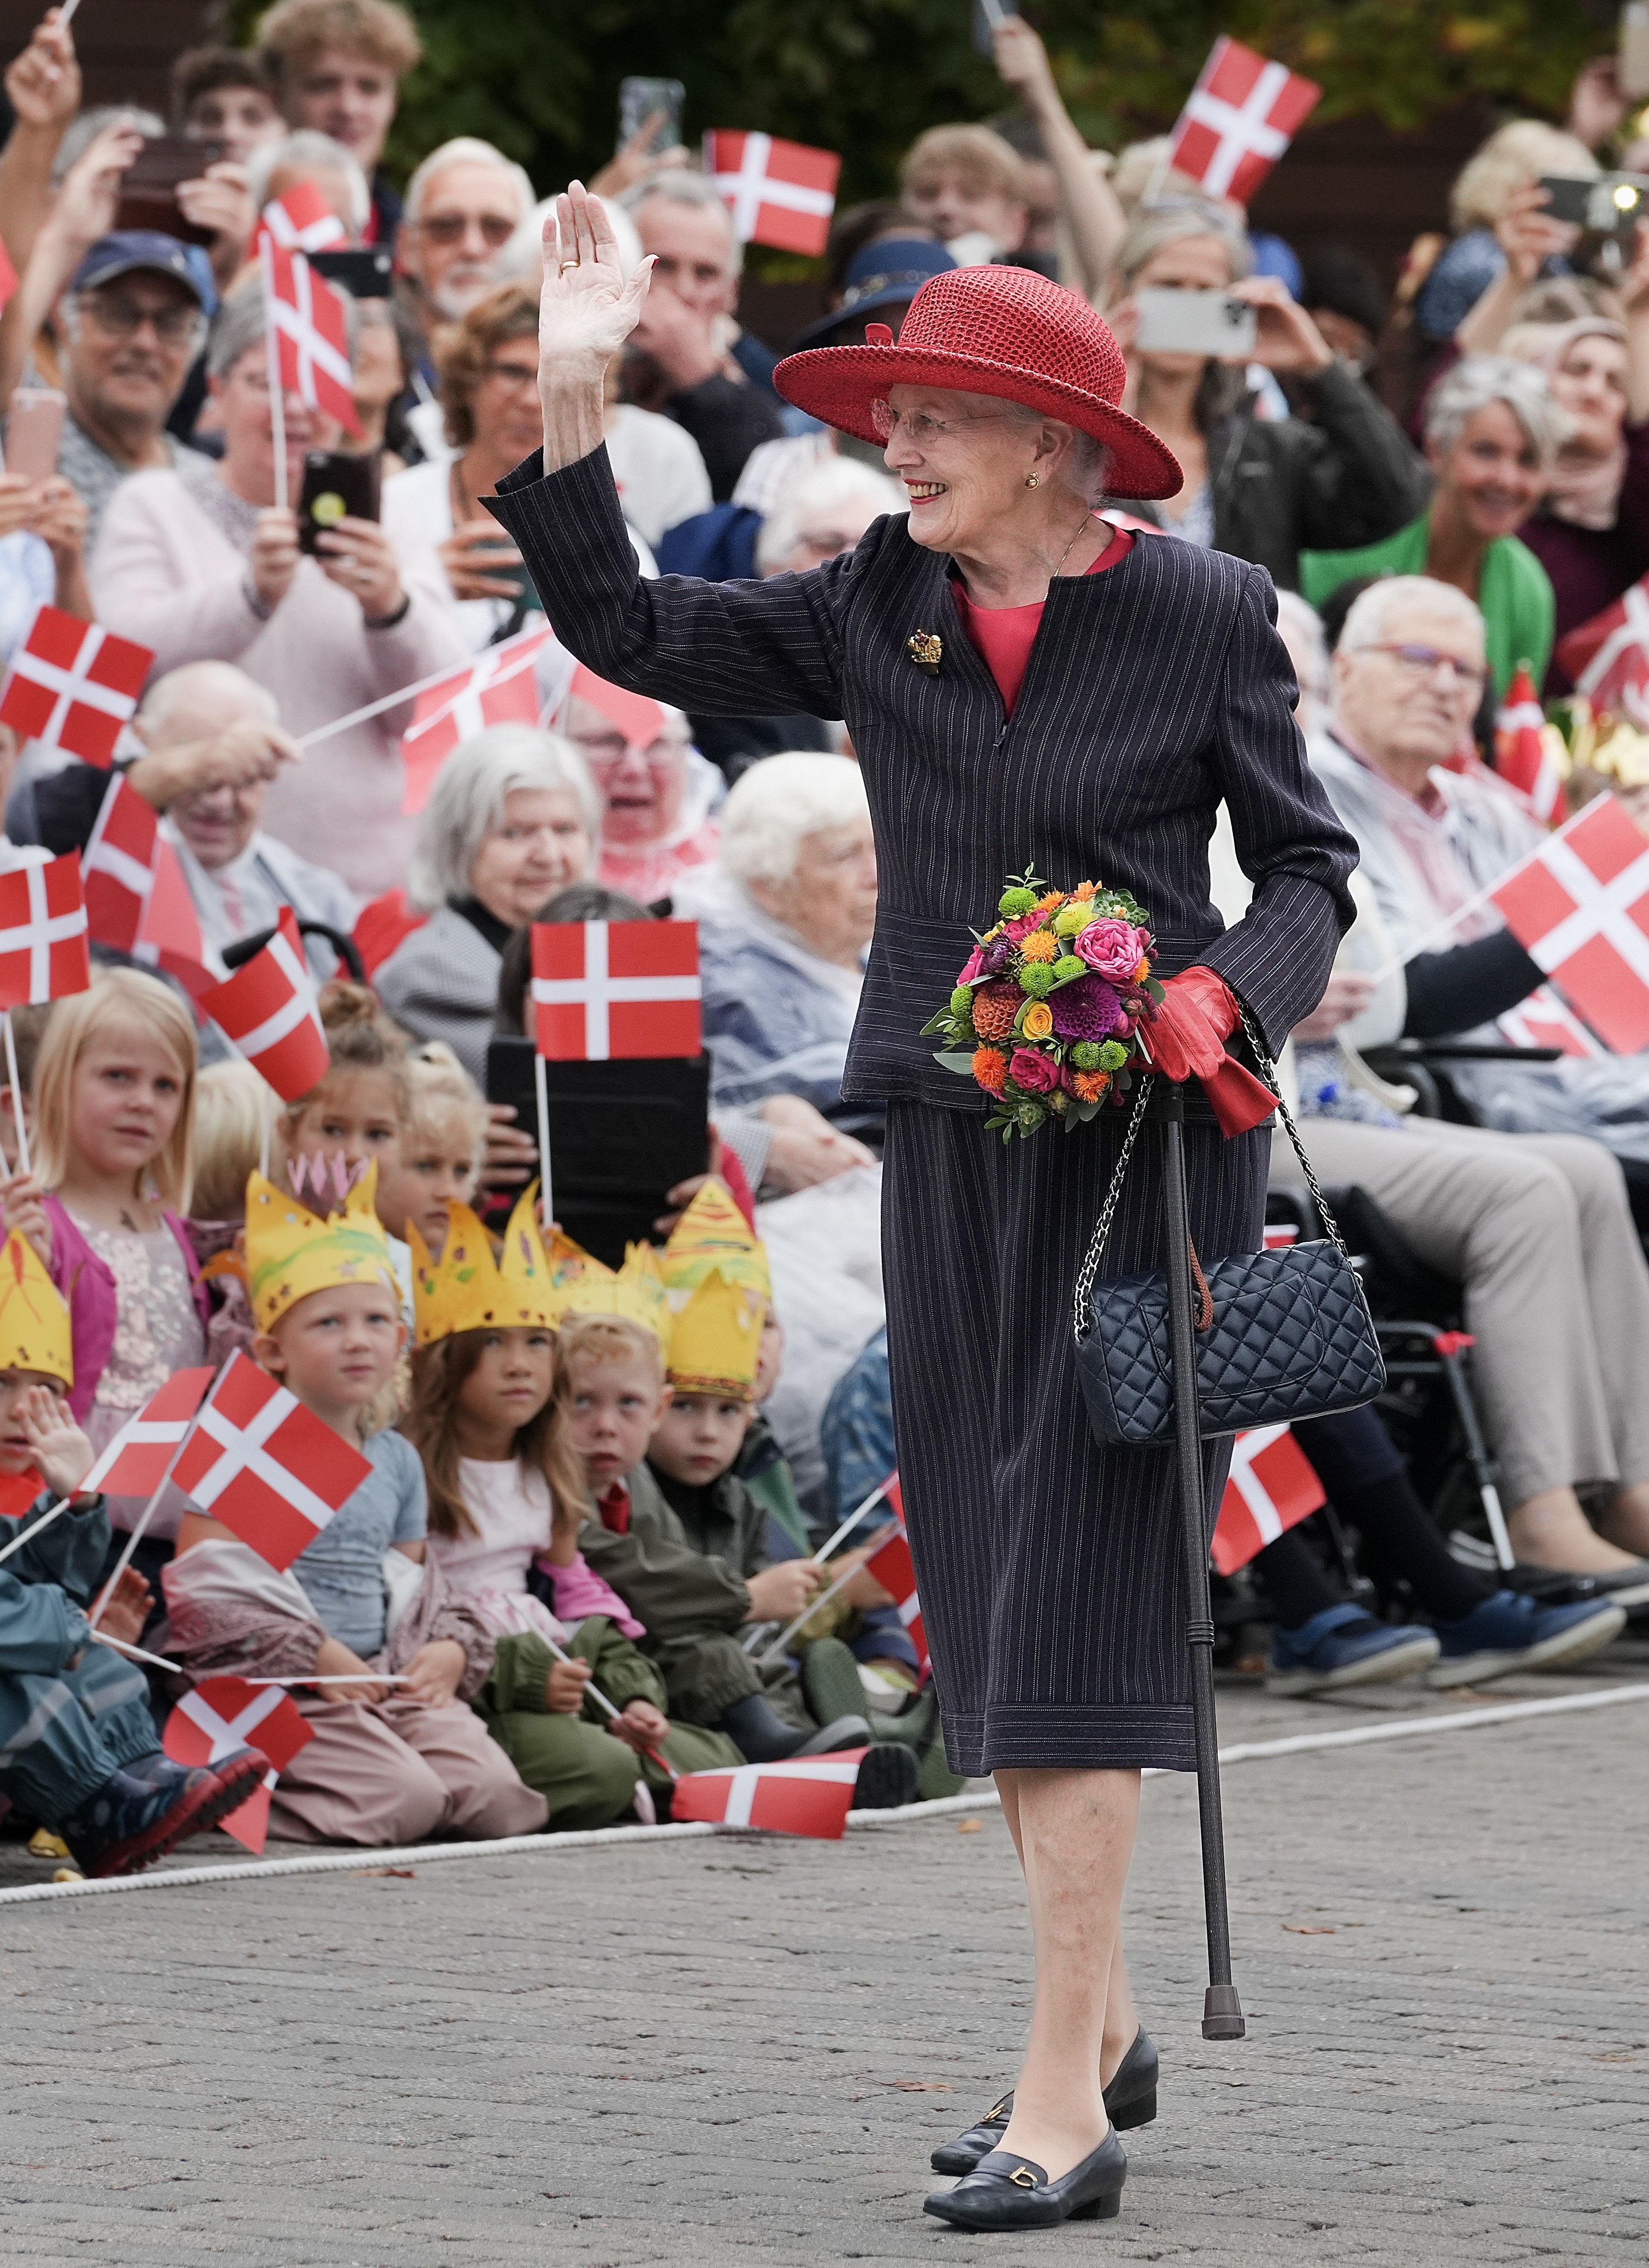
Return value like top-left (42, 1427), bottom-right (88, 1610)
top-left (1107, 204), bottom-right (1427, 589)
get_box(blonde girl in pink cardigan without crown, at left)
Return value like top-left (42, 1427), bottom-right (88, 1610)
top-left (4, 968), bottom-right (211, 1470)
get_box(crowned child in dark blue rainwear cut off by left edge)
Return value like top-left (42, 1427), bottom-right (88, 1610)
top-left (0, 1232), bottom-right (268, 1876)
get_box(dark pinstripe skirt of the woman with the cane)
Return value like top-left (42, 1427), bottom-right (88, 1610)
top-left (882, 1102), bottom-right (1268, 1774)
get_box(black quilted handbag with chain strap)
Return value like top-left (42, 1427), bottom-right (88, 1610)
top-left (1073, 1016), bottom-right (1386, 1449)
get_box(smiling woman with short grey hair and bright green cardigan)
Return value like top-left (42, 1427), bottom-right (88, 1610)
top-left (1300, 354), bottom-right (1570, 699)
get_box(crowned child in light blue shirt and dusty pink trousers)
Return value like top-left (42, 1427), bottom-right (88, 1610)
top-left (163, 1166), bottom-right (547, 1844)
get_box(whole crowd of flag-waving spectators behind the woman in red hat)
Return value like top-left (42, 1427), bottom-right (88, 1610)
top-left (0, 0), bottom-right (1649, 1866)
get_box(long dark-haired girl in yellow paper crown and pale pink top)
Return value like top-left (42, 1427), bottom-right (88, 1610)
top-left (406, 1191), bottom-right (742, 1828)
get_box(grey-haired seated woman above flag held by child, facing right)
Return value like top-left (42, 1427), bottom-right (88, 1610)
top-left (377, 723), bottom-right (601, 1086)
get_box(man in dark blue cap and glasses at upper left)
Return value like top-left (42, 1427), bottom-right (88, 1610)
top-left (57, 229), bottom-right (207, 551)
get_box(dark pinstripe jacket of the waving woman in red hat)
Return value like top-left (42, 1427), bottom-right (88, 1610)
top-left (486, 449), bottom-right (1356, 1109)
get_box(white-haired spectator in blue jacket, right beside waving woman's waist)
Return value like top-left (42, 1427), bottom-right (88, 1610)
top-left (701, 753), bottom-right (876, 1129)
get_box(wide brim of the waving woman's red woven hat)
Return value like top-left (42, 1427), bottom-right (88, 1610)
top-left (773, 335), bottom-right (1184, 497)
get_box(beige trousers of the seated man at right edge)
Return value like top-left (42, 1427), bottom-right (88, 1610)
top-left (1270, 1118), bottom-right (1649, 1508)
